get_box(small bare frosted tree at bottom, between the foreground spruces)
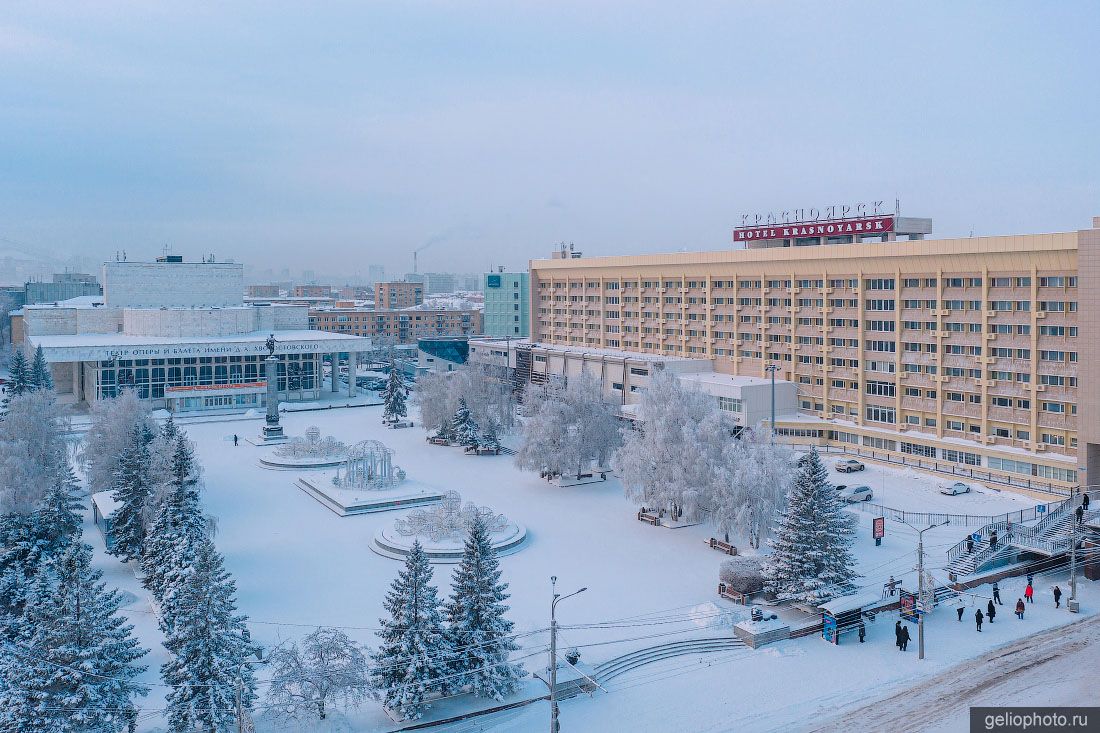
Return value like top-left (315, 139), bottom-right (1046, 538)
top-left (267, 628), bottom-right (370, 720)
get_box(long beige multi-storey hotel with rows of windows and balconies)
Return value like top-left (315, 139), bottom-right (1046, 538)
top-left (530, 215), bottom-right (1100, 488)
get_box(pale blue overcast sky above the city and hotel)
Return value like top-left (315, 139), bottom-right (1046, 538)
top-left (0, 0), bottom-right (1100, 274)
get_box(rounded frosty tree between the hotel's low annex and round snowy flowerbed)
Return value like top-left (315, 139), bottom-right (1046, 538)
top-left (516, 374), bottom-right (622, 475)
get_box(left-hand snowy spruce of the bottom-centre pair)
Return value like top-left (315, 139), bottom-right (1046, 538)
top-left (371, 540), bottom-right (450, 720)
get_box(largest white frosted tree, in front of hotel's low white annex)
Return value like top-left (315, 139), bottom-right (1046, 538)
top-left (615, 372), bottom-right (733, 518)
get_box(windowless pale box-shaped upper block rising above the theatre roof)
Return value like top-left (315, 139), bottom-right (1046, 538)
top-left (103, 262), bottom-right (244, 308)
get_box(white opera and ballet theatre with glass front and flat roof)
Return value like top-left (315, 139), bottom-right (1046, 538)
top-left (23, 255), bottom-right (371, 412)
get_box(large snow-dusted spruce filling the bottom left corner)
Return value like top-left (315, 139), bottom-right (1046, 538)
top-left (0, 541), bottom-right (147, 733)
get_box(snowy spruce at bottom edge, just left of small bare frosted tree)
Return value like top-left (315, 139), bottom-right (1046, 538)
top-left (161, 538), bottom-right (256, 733)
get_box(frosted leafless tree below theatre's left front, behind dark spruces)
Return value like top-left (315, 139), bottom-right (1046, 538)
top-left (80, 390), bottom-right (156, 492)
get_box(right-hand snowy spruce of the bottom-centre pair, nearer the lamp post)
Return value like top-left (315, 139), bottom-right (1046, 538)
top-left (447, 516), bottom-right (524, 700)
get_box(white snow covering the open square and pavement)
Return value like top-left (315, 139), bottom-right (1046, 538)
top-left (73, 407), bottom-right (1100, 733)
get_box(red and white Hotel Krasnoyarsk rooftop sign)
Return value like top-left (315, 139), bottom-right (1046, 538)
top-left (734, 201), bottom-right (895, 242)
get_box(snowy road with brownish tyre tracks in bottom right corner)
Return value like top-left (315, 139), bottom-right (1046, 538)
top-left (806, 616), bottom-right (1100, 733)
